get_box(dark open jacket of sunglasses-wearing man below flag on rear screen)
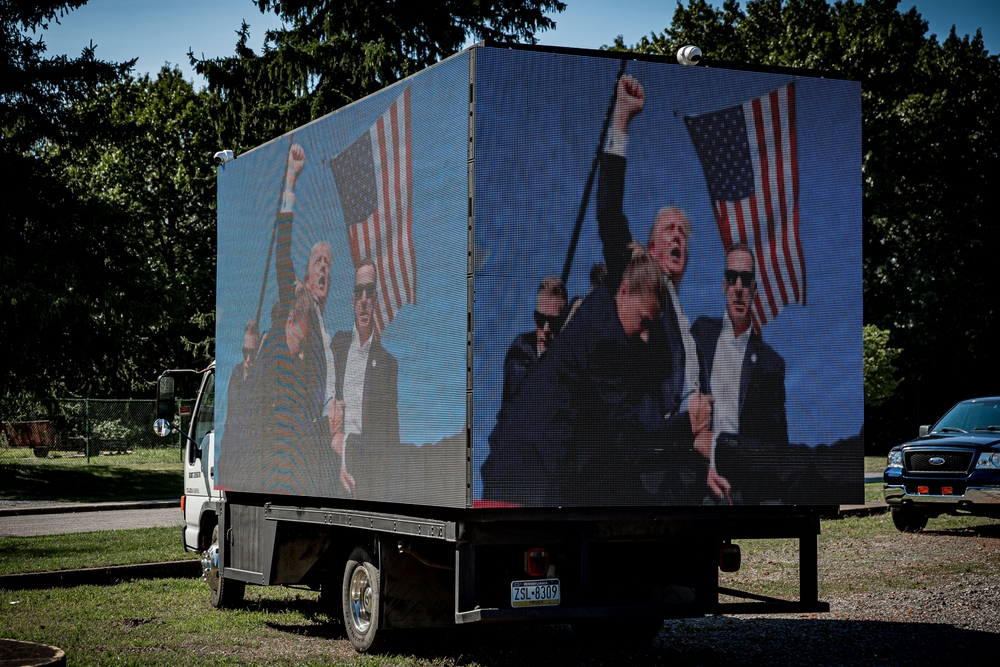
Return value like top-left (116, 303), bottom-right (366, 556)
top-left (691, 317), bottom-right (788, 504)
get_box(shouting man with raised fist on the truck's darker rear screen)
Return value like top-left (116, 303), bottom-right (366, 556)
top-left (597, 74), bottom-right (712, 504)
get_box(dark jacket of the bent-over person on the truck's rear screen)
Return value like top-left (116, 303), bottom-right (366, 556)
top-left (481, 285), bottom-right (665, 507)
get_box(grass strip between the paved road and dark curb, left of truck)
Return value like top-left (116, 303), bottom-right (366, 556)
top-left (0, 528), bottom-right (197, 574)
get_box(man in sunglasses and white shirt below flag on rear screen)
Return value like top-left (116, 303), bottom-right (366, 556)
top-left (691, 243), bottom-right (788, 504)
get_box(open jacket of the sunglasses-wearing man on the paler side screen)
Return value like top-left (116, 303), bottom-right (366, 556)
top-left (330, 331), bottom-right (399, 500)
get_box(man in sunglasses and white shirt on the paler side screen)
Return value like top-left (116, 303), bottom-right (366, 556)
top-left (331, 259), bottom-right (399, 500)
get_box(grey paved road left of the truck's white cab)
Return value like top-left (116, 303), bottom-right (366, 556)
top-left (0, 507), bottom-right (184, 538)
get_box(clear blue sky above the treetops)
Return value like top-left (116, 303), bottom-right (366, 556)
top-left (37, 0), bottom-right (1000, 84)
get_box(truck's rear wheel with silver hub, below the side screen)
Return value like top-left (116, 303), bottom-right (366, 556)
top-left (342, 547), bottom-right (384, 653)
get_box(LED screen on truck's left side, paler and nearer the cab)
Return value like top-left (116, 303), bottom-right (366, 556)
top-left (215, 53), bottom-right (469, 507)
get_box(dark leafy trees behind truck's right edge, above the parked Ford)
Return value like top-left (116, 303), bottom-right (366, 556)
top-left (610, 0), bottom-right (1000, 445)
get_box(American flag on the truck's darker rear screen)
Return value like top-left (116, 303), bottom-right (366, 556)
top-left (684, 83), bottom-right (806, 331)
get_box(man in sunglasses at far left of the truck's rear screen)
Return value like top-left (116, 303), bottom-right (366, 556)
top-left (503, 276), bottom-right (567, 402)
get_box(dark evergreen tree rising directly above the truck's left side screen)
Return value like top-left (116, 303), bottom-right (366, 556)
top-left (189, 0), bottom-right (565, 151)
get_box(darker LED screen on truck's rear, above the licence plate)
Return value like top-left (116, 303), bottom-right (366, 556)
top-left (473, 48), bottom-right (864, 508)
